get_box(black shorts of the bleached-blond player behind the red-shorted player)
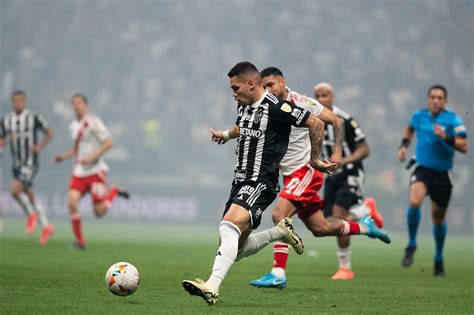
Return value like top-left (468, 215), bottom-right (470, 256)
top-left (324, 169), bottom-right (364, 217)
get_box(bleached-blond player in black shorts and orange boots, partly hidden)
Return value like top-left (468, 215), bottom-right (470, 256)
top-left (313, 83), bottom-right (383, 280)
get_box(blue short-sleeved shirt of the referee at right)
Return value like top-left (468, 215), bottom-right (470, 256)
top-left (410, 109), bottom-right (466, 172)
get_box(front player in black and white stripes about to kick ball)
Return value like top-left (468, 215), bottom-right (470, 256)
top-left (182, 62), bottom-right (336, 304)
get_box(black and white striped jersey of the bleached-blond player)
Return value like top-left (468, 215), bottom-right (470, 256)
top-left (321, 106), bottom-right (365, 174)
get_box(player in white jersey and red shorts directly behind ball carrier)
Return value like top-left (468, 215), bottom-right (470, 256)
top-left (250, 67), bottom-right (386, 289)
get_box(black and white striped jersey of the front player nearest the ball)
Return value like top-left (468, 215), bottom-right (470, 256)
top-left (234, 92), bottom-right (310, 189)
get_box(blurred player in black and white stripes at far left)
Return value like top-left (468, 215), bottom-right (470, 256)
top-left (0, 90), bottom-right (54, 244)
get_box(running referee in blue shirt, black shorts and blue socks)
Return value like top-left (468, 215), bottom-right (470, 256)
top-left (398, 85), bottom-right (468, 276)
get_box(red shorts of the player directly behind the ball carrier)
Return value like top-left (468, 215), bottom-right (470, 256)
top-left (280, 165), bottom-right (324, 219)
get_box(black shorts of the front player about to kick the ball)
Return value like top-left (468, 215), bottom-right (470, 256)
top-left (224, 181), bottom-right (278, 229)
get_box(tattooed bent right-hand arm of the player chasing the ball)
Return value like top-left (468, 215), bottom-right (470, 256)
top-left (305, 114), bottom-right (337, 175)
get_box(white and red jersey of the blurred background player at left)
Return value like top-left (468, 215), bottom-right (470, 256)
top-left (69, 114), bottom-right (110, 177)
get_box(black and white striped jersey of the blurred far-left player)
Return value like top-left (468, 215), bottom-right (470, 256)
top-left (0, 109), bottom-right (49, 169)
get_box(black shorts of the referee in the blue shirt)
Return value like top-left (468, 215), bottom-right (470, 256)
top-left (410, 166), bottom-right (453, 208)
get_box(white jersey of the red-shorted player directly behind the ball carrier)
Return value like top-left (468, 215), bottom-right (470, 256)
top-left (280, 87), bottom-right (324, 176)
